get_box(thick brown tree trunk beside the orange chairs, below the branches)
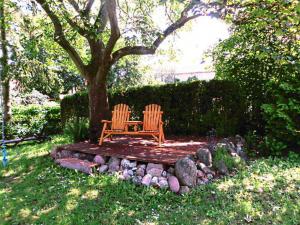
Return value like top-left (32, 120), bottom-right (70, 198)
top-left (88, 77), bottom-right (109, 143)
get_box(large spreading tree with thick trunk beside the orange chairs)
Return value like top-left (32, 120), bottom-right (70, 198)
top-left (36, 0), bottom-right (222, 142)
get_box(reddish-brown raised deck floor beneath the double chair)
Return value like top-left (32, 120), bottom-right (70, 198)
top-left (60, 136), bottom-right (207, 165)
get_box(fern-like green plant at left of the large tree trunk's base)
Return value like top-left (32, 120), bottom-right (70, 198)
top-left (64, 117), bottom-right (89, 143)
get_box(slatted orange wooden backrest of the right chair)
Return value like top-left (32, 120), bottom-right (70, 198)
top-left (143, 104), bottom-right (163, 131)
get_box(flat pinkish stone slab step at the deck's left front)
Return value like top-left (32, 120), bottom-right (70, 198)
top-left (56, 158), bottom-right (97, 174)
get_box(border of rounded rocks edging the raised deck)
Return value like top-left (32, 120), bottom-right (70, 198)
top-left (51, 135), bottom-right (246, 194)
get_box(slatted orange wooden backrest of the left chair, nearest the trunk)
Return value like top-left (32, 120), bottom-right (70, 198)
top-left (111, 104), bottom-right (130, 130)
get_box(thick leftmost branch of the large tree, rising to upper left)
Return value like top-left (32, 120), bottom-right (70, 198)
top-left (36, 0), bottom-right (86, 76)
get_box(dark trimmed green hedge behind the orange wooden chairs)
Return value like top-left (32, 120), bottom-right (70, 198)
top-left (61, 80), bottom-right (247, 136)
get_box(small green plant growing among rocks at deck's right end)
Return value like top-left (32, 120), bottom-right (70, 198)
top-left (213, 148), bottom-right (246, 171)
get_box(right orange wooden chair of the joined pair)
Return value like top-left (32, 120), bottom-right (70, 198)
top-left (138, 104), bottom-right (165, 146)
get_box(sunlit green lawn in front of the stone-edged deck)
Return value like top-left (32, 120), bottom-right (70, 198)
top-left (0, 136), bottom-right (300, 224)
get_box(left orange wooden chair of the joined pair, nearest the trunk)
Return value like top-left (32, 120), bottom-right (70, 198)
top-left (99, 104), bottom-right (130, 145)
